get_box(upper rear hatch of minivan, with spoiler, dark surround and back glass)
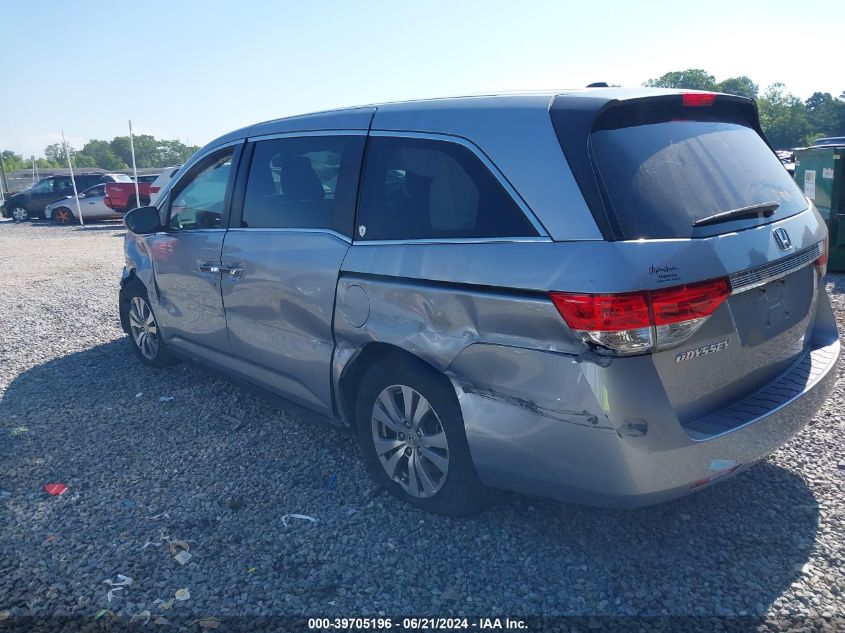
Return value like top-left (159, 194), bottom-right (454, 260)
top-left (551, 93), bottom-right (807, 240)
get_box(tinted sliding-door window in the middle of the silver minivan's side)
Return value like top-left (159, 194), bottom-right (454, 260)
top-left (241, 135), bottom-right (364, 235)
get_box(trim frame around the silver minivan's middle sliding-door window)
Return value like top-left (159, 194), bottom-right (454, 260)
top-left (227, 130), bottom-right (367, 236)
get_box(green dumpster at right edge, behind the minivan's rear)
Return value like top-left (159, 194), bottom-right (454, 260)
top-left (795, 145), bottom-right (845, 272)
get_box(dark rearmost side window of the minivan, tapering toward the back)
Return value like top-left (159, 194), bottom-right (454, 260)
top-left (356, 136), bottom-right (537, 240)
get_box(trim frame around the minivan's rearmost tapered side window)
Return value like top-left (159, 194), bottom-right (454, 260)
top-left (352, 130), bottom-right (552, 246)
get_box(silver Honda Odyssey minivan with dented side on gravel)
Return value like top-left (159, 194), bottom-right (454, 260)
top-left (120, 88), bottom-right (839, 514)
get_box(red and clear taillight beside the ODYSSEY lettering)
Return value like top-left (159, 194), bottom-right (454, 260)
top-left (551, 278), bottom-right (731, 355)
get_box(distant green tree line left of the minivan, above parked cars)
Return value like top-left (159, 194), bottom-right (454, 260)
top-left (0, 134), bottom-right (199, 171)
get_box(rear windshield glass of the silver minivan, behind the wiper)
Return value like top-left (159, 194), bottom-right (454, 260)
top-left (591, 120), bottom-right (807, 239)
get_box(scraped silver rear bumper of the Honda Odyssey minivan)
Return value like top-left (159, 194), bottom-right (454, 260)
top-left (448, 296), bottom-right (840, 507)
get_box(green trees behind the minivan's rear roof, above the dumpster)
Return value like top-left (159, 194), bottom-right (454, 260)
top-left (643, 68), bottom-right (845, 149)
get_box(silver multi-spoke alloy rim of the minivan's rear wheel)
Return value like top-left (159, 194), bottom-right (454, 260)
top-left (372, 385), bottom-right (449, 498)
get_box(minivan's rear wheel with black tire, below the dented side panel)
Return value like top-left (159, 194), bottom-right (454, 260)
top-left (356, 355), bottom-right (489, 516)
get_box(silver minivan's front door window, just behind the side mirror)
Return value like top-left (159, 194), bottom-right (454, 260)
top-left (168, 149), bottom-right (234, 231)
